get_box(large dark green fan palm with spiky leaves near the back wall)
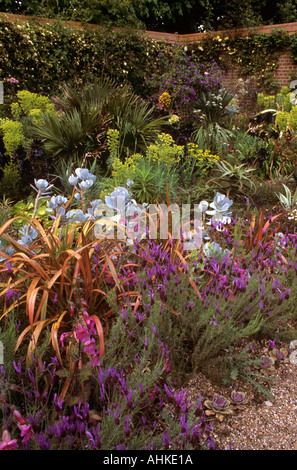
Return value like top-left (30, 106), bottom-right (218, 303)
top-left (32, 78), bottom-right (168, 160)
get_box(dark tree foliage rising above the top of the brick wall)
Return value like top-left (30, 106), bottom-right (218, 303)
top-left (0, 0), bottom-right (297, 34)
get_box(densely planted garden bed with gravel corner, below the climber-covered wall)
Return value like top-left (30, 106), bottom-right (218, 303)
top-left (0, 42), bottom-right (297, 451)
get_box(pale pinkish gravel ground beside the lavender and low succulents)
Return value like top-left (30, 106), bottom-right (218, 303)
top-left (182, 342), bottom-right (297, 450)
